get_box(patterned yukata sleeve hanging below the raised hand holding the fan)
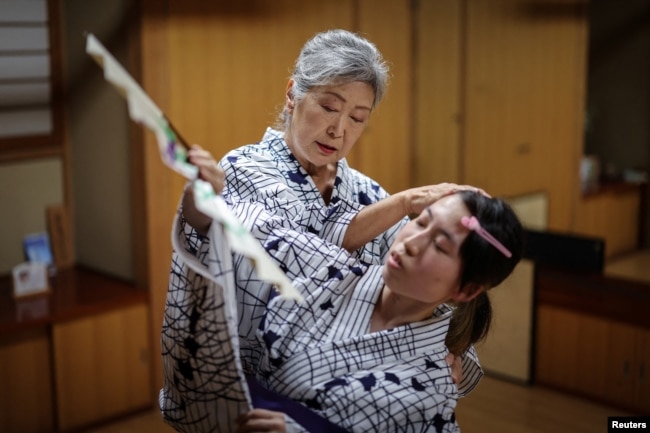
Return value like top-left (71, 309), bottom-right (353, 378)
top-left (159, 199), bottom-right (251, 433)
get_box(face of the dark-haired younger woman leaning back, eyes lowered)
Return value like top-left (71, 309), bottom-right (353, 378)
top-left (383, 194), bottom-right (470, 306)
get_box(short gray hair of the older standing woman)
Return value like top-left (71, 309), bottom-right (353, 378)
top-left (280, 29), bottom-right (389, 127)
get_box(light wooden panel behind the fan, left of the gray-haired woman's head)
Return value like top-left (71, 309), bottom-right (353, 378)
top-left (167, 0), bottom-right (352, 164)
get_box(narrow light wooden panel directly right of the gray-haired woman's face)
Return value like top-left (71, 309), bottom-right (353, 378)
top-left (349, 0), bottom-right (414, 193)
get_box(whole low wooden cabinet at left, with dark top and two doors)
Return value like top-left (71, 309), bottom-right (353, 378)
top-left (0, 268), bottom-right (157, 433)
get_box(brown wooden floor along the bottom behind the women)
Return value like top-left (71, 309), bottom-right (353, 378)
top-left (85, 376), bottom-right (630, 433)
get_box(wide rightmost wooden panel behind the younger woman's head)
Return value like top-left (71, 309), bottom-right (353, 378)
top-left (463, 0), bottom-right (587, 230)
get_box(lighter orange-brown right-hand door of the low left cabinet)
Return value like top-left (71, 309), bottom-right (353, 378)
top-left (53, 305), bottom-right (151, 431)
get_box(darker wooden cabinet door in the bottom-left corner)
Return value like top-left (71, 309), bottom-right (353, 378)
top-left (0, 329), bottom-right (54, 433)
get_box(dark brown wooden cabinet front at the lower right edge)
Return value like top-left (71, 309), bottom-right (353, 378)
top-left (535, 305), bottom-right (650, 414)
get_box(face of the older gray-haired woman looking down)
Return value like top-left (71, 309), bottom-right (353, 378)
top-left (285, 81), bottom-right (375, 173)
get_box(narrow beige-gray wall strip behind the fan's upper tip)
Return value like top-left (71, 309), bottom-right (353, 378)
top-left (62, 0), bottom-right (134, 279)
